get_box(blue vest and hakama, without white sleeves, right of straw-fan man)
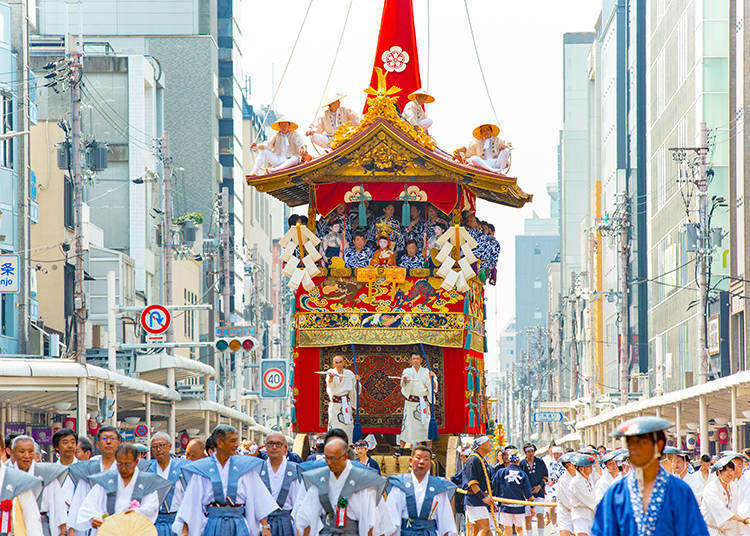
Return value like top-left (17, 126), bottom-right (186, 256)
top-left (182, 455), bottom-right (263, 536)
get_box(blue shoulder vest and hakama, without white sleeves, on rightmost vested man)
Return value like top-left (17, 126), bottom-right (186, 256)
top-left (386, 473), bottom-right (456, 536)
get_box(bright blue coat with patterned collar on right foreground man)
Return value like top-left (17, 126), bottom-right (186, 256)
top-left (591, 468), bottom-right (709, 536)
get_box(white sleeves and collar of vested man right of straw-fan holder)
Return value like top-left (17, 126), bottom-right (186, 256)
top-left (172, 456), bottom-right (278, 536)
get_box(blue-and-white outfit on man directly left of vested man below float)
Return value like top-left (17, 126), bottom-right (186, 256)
top-left (260, 457), bottom-right (304, 536)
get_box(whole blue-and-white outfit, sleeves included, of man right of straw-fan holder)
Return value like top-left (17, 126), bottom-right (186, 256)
top-left (172, 455), bottom-right (278, 536)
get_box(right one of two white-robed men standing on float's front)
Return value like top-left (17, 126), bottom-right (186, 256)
top-left (399, 350), bottom-right (438, 448)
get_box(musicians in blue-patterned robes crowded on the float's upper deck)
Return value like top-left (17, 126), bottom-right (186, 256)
top-left (288, 201), bottom-right (500, 284)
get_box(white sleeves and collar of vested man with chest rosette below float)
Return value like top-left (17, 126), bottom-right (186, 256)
top-left (296, 461), bottom-right (378, 536)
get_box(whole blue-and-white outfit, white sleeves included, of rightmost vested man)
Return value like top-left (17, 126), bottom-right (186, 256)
top-left (385, 473), bottom-right (458, 536)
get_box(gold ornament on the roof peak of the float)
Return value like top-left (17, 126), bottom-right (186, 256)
top-left (331, 67), bottom-right (435, 149)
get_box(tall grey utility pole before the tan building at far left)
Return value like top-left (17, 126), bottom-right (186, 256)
top-left (67, 35), bottom-right (86, 363)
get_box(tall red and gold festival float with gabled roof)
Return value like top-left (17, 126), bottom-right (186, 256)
top-left (246, 0), bottom-right (531, 468)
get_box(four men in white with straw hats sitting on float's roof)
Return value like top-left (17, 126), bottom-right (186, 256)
top-left (250, 89), bottom-right (512, 176)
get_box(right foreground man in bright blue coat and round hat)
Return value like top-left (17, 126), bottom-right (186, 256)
top-left (591, 416), bottom-right (709, 536)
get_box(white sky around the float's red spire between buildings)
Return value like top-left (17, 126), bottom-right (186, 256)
top-left (243, 0), bottom-right (601, 362)
